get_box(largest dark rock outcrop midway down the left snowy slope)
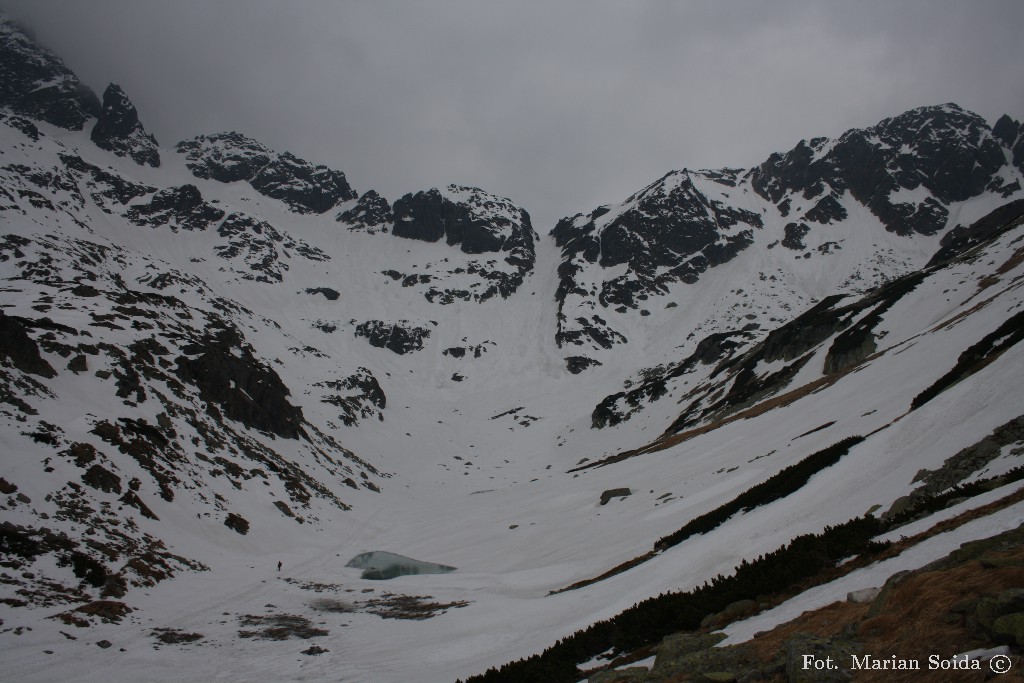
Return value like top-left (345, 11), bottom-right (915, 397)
top-left (176, 327), bottom-right (303, 438)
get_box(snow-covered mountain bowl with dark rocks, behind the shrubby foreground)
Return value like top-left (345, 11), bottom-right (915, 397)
top-left (0, 15), bottom-right (1024, 681)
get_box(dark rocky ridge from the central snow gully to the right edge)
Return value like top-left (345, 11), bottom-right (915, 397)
top-left (551, 104), bottom-right (1024, 358)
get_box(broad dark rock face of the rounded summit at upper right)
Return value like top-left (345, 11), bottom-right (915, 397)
top-left (752, 104), bottom-right (1011, 234)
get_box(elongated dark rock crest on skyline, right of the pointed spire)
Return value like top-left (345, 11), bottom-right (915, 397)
top-left (175, 132), bottom-right (357, 213)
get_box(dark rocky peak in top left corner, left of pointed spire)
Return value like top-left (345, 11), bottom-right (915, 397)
top-left (0, 18), bottom-right (100, 130)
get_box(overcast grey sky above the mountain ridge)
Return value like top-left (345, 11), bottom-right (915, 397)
top-left (0, 0), bottom-right (1024, 232)
